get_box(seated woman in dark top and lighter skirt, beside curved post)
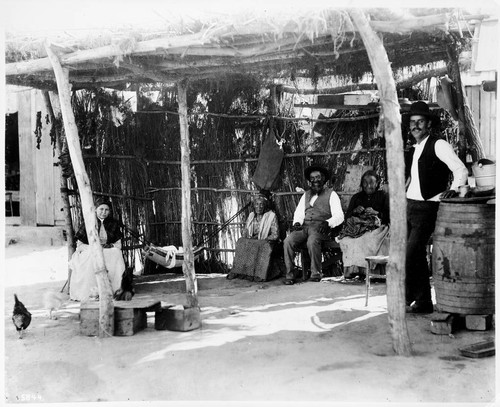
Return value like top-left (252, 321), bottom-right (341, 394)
top-left (338, 170), bottom-right (389, 278)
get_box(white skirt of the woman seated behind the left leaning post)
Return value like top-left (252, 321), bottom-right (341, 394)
top-left (69, 245), bottom-right (125, 301)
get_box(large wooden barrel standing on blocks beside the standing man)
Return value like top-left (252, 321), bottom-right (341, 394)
top-left (432, 202), bottom-right (495, 315)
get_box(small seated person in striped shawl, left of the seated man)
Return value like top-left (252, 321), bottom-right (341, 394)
top-left (227, 194), bottom-right (279, 281)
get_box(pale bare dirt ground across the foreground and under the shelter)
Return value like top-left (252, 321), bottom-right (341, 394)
top-left (4, 243), bottom-right (496, 405)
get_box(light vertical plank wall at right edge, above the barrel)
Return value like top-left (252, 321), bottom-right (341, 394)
top-left (465, 85), bottom-right (497, 160)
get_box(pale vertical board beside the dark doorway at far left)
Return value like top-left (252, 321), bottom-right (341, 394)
top-left (18, 90), bottom-right (36, 226)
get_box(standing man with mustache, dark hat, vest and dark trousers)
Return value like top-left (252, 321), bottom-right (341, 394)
top-left (405, 101), bottom-right (468, 314)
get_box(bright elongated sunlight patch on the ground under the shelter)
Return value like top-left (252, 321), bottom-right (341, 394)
top-left (136, 295), bottom-right (387, 364)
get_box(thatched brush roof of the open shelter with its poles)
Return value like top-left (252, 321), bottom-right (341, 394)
top-left (5, 3), bottom-right (489, 89)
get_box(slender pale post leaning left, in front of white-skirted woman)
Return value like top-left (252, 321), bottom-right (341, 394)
top-left (45, 43), bottom-right (115, 338)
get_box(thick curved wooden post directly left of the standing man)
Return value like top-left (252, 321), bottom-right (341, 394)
top-left (349, 9), bottom-right (412, 356)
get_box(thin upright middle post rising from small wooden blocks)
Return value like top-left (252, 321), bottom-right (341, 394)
top-left (177, 81), bottom-right (198, 308)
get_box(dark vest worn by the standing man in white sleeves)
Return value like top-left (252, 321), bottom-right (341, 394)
top-left (406, 136), bottom-right (451, 200)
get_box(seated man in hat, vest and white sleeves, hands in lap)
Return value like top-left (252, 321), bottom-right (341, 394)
top-left (283, 166), bottom-right (344, 285)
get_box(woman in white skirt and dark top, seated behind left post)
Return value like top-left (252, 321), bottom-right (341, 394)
top-left (69, 199), bottom-right (125, 301)
